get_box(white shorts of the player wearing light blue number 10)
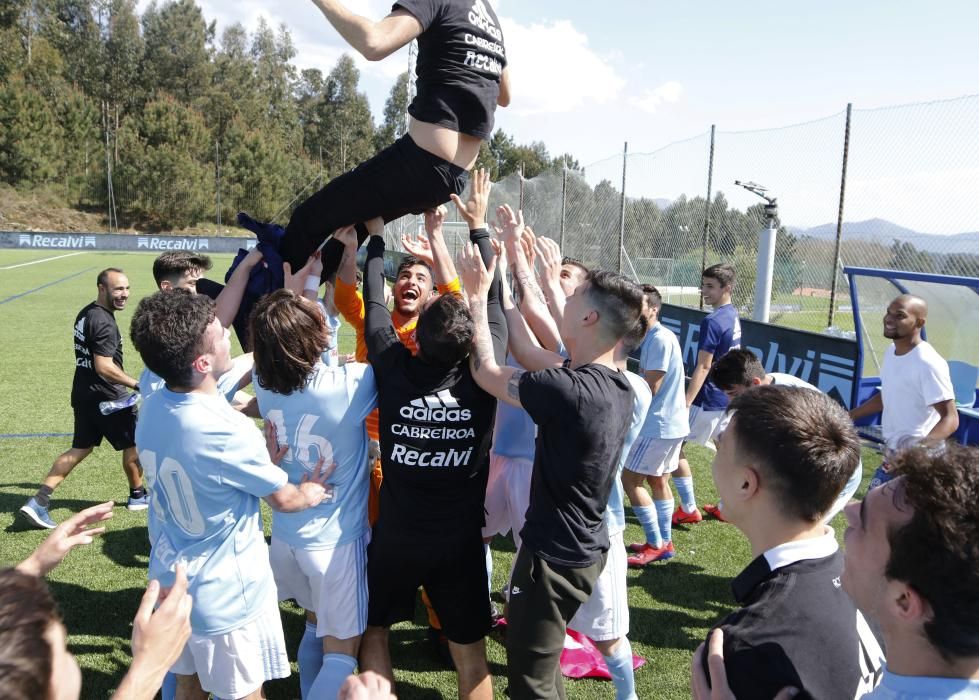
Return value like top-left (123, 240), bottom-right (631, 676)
top-left (170, 595), bottom-right (290, 699)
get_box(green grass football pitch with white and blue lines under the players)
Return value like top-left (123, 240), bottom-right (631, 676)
top-left (0, 250), bottom-right (879, 700)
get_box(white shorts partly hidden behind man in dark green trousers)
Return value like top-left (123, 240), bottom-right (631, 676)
top-left (568, 532), bottom-right (629, 642)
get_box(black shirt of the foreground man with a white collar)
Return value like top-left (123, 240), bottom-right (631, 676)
top-left (704, 548), bottom-right (882, 700)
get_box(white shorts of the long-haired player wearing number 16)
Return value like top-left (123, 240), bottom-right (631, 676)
top-left (269, 534), bottom-right (370, 639)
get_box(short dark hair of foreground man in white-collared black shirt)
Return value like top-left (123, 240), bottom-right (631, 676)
top-left (727, 386), bottom-right (860, 523)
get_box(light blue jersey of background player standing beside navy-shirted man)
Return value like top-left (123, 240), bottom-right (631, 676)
top-left (639, 323), bottom-right (690, 440)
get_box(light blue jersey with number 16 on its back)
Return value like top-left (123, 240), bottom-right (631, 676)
top-left (253, 362), bottom-right (377, 549)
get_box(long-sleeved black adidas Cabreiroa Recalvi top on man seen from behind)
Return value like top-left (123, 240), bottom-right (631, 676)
top-left (364, 236), bottom-right (506, 536)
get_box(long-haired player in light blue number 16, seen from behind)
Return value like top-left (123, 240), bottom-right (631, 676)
top-left (250, 288), bottom-right (377, 698)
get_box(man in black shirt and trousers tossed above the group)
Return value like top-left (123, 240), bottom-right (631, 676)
top-left (282, 0), bottom-right (510, 279)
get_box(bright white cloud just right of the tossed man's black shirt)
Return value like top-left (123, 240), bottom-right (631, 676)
top-left (500, 17), bottom-right (625, 115)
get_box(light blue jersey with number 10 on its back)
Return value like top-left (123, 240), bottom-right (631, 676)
top-left (136, 387), bottom-right (288, 635)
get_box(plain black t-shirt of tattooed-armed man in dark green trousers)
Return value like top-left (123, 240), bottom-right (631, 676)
top-left (520, 364), bottom-right (635, 567)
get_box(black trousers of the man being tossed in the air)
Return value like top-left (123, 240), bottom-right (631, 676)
top-left (280, 134), bottom-right (469, 279)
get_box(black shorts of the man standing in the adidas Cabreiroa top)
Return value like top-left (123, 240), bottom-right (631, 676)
top-left (367, 516), bottom-right (490, 644)
